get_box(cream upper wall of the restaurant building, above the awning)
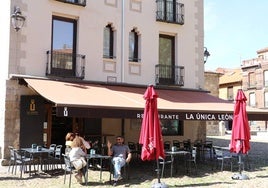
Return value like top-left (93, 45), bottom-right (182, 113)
top-left (10, 0), bottom-right (204, 88)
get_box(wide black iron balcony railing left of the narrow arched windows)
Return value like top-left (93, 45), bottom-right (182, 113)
top-left (46, 51), bottom-right (86, 79)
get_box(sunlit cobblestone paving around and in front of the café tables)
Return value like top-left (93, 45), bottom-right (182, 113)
top-left (0, 135), bottom-right (268, 188)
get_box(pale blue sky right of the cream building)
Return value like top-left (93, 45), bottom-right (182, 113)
top-left (204, 0), bottom-right (268, 70)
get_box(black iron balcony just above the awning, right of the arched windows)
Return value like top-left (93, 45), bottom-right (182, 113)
top-left (155, 64), bottom-right (184, 86)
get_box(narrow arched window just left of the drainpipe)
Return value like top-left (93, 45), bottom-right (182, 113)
top-left (103, 24), bottom-right (114, 59)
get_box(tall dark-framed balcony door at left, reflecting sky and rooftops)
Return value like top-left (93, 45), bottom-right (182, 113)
top-left (50, 16), bottom-right (77, 77)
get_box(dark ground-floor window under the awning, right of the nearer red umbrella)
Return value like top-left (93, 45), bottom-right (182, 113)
top-left (160, 120), bottom-right (183, 136)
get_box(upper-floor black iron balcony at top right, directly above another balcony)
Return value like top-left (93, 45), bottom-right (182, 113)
top-left (156, 0), bottom-right (184, 25)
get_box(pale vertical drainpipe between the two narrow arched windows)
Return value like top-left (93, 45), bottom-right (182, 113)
top-left (121, 0), bottom-right (125, 83)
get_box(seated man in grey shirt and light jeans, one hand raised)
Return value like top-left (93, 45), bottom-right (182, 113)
top-left (107, 136), bottom-right (131, 184)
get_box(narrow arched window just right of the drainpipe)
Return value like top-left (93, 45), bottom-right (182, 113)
top-left (129, 29), bottom-right (139, 62)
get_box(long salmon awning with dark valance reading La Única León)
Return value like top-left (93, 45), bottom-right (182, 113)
top-left (25, 78), bottom-right (268, 120)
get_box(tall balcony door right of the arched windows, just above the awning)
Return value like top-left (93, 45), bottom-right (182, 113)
top-left (159, 35), bottom-right (175, 84)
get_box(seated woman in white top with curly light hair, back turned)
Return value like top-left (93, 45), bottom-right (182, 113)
top-left (69, 136), bottom-right (87, 183)
